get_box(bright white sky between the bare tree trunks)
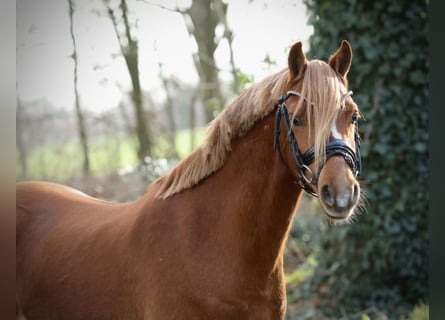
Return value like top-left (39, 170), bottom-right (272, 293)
top-left (17, 0), bottom-right (313, 112)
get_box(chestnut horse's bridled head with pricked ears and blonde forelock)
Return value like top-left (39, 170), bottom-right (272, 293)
top-left (276, 41), bottom-right (361, 220)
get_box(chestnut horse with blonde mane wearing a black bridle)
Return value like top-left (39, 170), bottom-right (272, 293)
top-left (16, 41), bottom-right (361, 320)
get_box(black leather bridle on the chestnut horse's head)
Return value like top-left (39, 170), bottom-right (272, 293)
top-left (274, 91), bottom-right (362, 197)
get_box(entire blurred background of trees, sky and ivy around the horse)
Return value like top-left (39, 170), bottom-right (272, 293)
top-left (16, 0), bottom-right (429, 319)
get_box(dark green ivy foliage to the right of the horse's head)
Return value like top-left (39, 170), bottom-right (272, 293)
top-left (305, 0), bottom-right (429, 318)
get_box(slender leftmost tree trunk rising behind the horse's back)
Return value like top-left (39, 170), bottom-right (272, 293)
top-left (68, 0), bottom-right (90, 176)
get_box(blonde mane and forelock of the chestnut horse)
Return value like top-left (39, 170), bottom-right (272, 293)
top-left (153, 60), bottom-right (346, 199)
